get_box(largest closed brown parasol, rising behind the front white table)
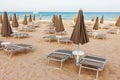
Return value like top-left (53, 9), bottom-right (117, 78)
top-left (70, 10), bottom-right (89, 49)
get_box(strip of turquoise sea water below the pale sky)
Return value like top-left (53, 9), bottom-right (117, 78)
top-left (0, 12), bottom-right (120, 21)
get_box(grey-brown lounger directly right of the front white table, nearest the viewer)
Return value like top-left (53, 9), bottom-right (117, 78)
top-left (79, 55), bottom-right (107, 80)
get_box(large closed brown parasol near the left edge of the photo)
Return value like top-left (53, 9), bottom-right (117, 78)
top-left (1, 12), bottom-right (12, 37)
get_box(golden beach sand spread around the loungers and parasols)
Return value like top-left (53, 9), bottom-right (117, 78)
top-left (0, 20), bottom-right (120, 80)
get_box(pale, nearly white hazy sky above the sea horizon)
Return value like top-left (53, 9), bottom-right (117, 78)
top-left (0, 0), bottom-right (120, 12)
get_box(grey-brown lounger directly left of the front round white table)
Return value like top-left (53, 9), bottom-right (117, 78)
top-left (47, 50), bottom-right (72, 69)
